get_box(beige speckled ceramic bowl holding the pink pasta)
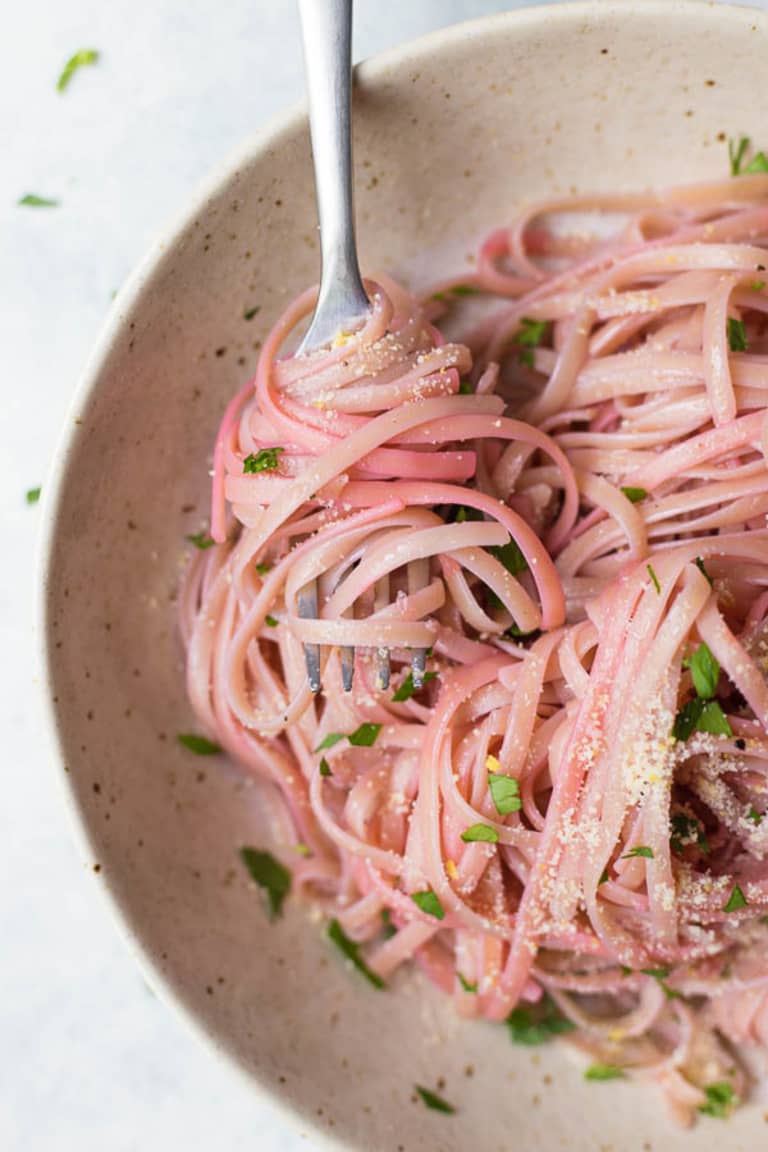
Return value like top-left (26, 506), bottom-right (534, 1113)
top-left (41, 0), bottom-right (768, 1152)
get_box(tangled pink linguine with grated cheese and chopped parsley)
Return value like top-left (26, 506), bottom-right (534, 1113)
top-left (182, 174), bottom-right (768, 1122)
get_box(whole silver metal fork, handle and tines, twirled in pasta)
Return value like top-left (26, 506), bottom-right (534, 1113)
top-left (298, 0), bottom-right (428, 692)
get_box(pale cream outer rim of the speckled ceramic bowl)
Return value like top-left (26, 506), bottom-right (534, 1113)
top-left (33, 0), bottom-right (768, 1152)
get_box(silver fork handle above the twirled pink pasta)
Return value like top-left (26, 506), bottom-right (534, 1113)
top-left (298, 0), bottom-right (370, 348)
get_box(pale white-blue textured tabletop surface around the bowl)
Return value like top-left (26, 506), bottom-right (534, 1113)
top-left (0, 0), bottom-right (768, 1152)
